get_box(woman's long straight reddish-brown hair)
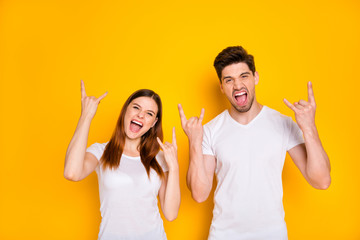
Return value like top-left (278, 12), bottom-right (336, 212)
top-left (100, 89), bottom-right (164, 178)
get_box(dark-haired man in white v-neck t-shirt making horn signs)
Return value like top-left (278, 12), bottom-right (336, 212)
top-left (179, 46), bottom-right (331, 240)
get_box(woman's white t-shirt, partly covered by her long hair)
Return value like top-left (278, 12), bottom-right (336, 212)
top-left (86, 143), bottom-right (168, 240)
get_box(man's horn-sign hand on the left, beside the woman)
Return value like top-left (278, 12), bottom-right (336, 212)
top-left (178, 104), bottom-right (205, 144)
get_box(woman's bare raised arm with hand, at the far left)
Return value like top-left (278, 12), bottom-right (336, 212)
top-left (64, 81), bottom-right (107, 181)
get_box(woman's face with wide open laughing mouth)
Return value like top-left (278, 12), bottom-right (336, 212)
top-left (124, 97), bottom-right (158, 139)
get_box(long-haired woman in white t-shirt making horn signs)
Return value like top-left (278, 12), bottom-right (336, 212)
top-left (64, 81), bottom-right (180, 240)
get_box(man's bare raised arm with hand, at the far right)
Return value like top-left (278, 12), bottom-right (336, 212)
top-left (284, 82), bottom-right (331, 189)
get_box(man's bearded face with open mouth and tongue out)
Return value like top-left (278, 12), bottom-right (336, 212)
top-left (220, 62), bottom-right (259, 113)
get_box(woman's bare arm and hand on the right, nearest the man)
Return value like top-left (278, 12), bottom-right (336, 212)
top-left (157, 127), bottom-right (180, 221)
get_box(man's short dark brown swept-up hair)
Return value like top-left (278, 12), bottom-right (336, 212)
top-left (214, 46), bottom-right (256, 83)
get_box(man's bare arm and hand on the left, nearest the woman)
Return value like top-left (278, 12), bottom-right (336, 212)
top-left (178, 104), bottom-right (216, 203)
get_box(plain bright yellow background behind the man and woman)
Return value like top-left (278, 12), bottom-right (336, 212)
top-left (0, 0), bottom-right (360, 240)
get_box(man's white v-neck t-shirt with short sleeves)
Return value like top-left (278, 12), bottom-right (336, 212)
top-left (203, 106), bottom-right (304, 240)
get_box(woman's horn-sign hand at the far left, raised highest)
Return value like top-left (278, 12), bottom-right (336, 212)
top-left (81, 80), bottom-right (108, 120)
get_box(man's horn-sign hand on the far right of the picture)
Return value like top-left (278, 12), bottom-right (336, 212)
top-left (284, 82), bottom-right (316, 132)
